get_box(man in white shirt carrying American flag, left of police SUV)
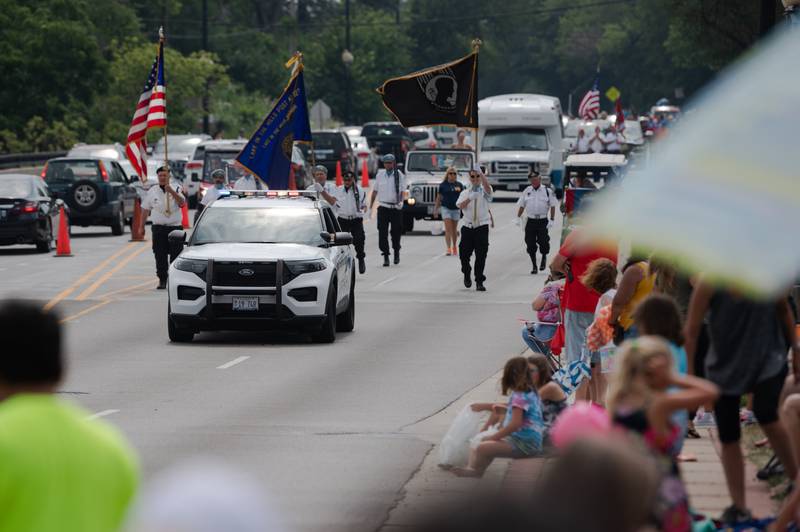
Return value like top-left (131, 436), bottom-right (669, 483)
top-left (141, 166), bottom-right (186, 290)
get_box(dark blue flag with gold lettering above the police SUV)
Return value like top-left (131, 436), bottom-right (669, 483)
top-left (236, 55), bottom-right (311, 190)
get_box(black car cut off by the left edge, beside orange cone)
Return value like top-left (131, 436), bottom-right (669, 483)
top-left (0, 174), bottom-right (64, 253)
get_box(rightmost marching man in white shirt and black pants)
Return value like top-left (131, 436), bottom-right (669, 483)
top-left (517, 170), bottom-right (558, 274)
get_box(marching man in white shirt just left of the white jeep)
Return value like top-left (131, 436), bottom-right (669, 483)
top-left (369, 153), bottom-right (408, 266)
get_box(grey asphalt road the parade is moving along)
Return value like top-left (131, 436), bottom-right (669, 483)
top-left (0, 194), bottom-right (558, 531)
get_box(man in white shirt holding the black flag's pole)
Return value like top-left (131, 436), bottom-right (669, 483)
top-left (456, 167), bottom-right (492, 292)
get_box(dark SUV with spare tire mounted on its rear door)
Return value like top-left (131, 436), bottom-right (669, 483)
top-left (41, 157), bottom-right (141, 235)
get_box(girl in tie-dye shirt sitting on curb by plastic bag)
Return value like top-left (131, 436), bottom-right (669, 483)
top-left (452, 357), bottom-right (544, 477)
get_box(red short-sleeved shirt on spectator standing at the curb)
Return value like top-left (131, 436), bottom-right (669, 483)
top-left (558, 231), bottom-right (618, 314)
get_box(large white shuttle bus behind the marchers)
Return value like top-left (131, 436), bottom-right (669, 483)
top-left (478, 94), bottom-right (564, 196)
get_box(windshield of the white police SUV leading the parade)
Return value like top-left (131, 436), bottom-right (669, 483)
top-left (192, 207), bottom-right (324, 246)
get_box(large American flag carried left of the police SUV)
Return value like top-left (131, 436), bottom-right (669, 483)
top-left (125, 40), bottom-right (167, 181)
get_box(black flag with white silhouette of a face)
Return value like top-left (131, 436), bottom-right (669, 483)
top-left (377, 50), bottom-right (478, 128)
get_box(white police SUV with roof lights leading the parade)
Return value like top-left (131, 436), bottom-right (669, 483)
top-left (167, 191), bottom-right (356, 342)
